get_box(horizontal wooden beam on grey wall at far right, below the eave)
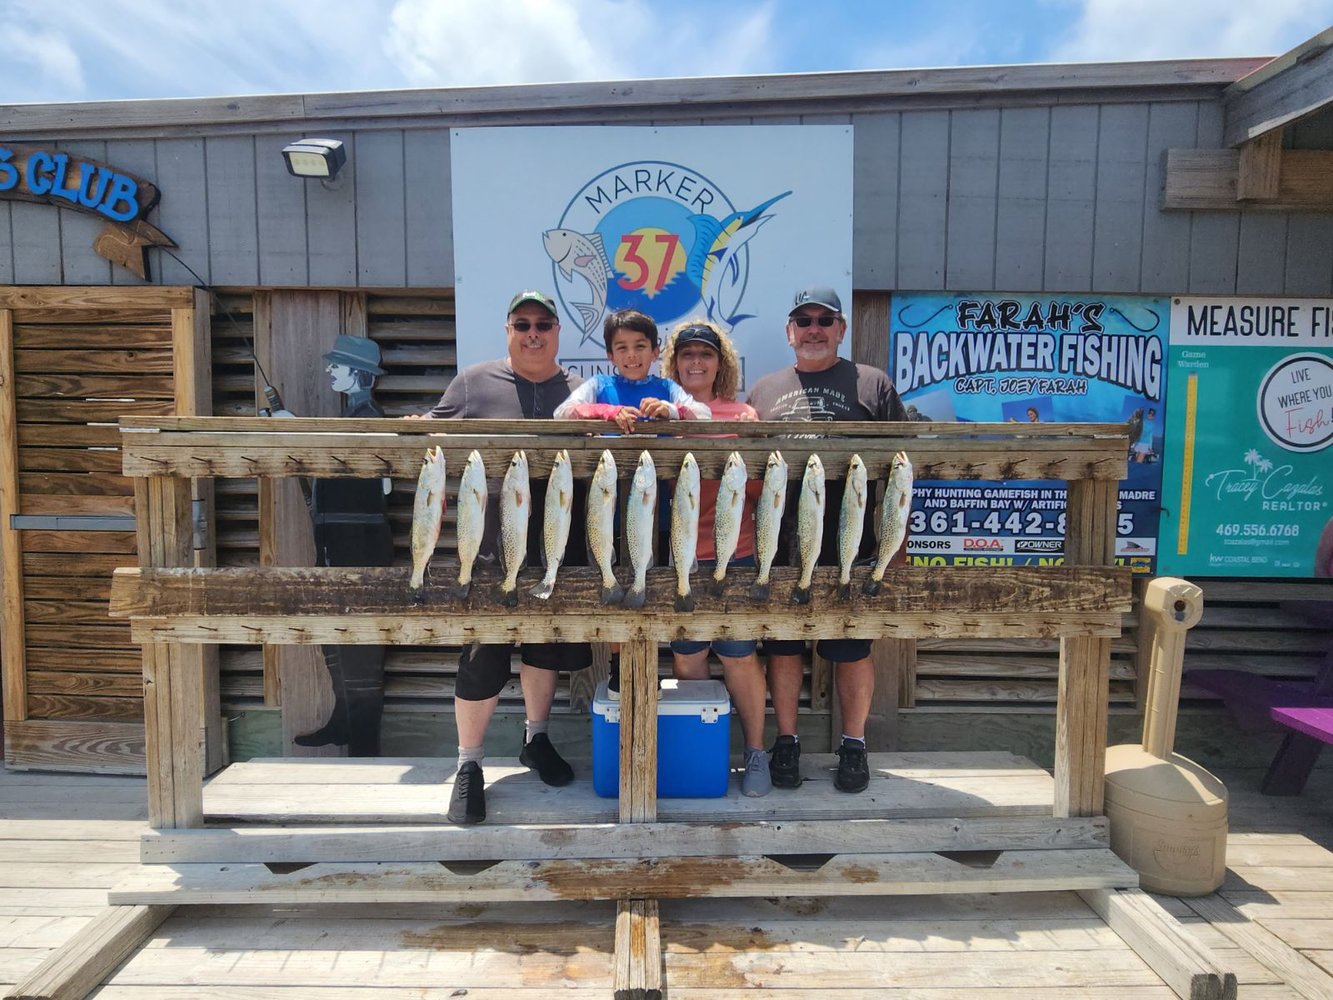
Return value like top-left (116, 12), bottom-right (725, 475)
top-left (1161, 149), bottom-right (1333, 212)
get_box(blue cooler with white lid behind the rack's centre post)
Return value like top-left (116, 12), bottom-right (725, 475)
top-left (592, 680), bottom-right (732, 799)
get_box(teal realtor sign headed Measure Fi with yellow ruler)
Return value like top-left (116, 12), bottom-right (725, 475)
top-left (1160, 297), bottom-right (1333, 577)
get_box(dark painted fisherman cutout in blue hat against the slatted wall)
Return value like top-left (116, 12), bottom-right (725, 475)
top-left (295, 333), bottom-right (393, 757)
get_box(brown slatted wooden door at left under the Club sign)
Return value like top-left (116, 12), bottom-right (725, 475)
top-left (0, 287), bottom-right (223, 773)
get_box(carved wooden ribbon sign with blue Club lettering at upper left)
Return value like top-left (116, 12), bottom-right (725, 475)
top-left (0, 143), bottom-right (176, 279)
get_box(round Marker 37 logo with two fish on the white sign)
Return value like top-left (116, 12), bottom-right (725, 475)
top-left (541, 160), bottom-right (792, 347)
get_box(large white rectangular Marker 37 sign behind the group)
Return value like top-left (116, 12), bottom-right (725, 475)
top-left (451, 125), bottom-right (852, 397)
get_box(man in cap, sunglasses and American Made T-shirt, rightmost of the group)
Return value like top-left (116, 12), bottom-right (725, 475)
top-left (749, 287), bottom-right (908, 792)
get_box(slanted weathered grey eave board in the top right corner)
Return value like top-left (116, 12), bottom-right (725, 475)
top-left (1222, 28), bottom-right (1333, 147)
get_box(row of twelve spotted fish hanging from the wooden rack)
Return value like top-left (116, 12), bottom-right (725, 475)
top-left (409, 448), bottom-right (912, 611)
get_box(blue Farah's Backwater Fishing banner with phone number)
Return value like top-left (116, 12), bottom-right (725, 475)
top-left (888, 292), bottom-right (1169, 573)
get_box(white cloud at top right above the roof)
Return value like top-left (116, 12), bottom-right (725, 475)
top-left (1050, 0), bottom-right (1333, 61)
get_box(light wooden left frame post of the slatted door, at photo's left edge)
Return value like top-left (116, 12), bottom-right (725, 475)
top-left (0, 308), bottom-right (28, 723)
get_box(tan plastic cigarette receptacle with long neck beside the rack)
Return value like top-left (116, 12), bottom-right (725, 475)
top-left (1106, 576), bottom-right (1226, 896)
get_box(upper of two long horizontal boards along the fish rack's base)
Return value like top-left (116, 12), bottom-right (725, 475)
top-left (140, 816), bottom-right (1109, 864)
